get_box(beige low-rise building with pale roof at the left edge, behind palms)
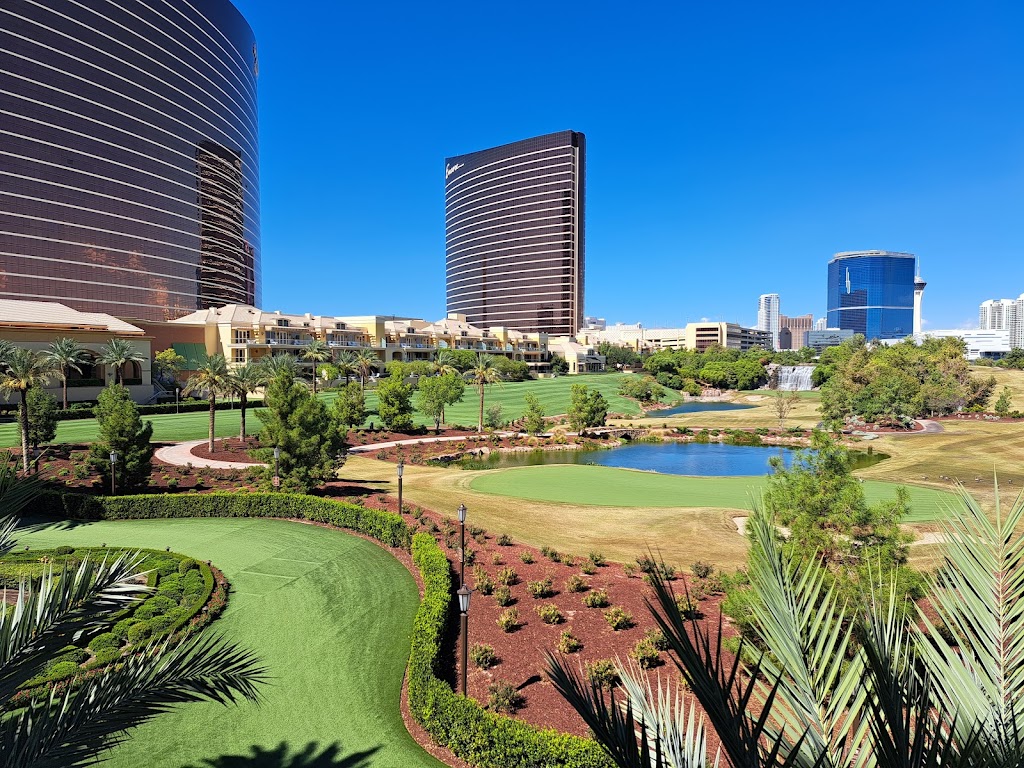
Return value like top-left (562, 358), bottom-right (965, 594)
top-left (0, 299), bottom-right (155, 402)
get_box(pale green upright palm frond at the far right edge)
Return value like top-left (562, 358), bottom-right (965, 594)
top-left (921, 484), bottom-right (1024, 757)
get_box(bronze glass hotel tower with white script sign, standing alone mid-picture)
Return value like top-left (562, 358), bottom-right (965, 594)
top-left (444, 131), bottom-right (586, 336)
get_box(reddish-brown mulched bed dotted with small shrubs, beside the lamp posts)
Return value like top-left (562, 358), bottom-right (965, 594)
top-left (364, 494), bottom-right (737, 735)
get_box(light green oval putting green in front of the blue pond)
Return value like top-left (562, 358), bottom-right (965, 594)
top-left (470, 464), bottom-right (954, 522)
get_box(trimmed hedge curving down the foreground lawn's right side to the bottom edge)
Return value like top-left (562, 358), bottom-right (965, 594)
top-left (409, 534), bottom-right (613, 768)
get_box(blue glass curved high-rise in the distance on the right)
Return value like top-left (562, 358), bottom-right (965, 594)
top-left (828, 251), bottom-right (916, 340)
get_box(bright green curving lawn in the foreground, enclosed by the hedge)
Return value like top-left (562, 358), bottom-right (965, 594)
top-left (18, 519), bottom-right (442, 768)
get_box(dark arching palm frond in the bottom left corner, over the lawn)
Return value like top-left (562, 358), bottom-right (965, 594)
top-left (0, 635), bottom-right (268, 768)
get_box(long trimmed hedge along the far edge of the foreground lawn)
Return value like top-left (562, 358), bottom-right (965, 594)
top-left (35, 492), bottom-right (410, 550)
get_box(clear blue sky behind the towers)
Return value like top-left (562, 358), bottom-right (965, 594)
top-left (236, 0), bottom-right (1024, 328)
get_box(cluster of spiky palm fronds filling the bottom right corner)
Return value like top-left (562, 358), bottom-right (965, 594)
top-left (549, 488), bottom-right (1024, 768)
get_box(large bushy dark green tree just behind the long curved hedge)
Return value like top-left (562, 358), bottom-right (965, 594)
top-left (256, 370), bottom-right (345, 492)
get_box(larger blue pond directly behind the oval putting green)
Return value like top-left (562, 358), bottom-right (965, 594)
top-left (452, 442), bottom-right (889, 477)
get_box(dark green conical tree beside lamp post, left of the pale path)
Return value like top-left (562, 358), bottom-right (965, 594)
top-left (89, 384), bottom-right (153, 488)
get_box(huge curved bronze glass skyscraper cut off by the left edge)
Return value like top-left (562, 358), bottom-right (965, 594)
top-left (0, 0), bottom-right (260, 319)
